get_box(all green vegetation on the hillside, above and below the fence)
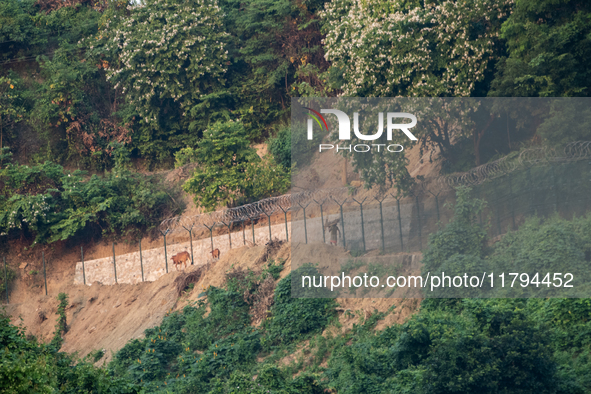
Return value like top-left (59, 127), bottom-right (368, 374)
top-left (0, 0), bottom-right (591, 394)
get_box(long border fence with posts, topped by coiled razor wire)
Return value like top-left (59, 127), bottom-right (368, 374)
top-left (4, 141), bottom-right (591, 303)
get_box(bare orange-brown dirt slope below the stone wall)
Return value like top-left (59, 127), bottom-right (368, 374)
top-left (7, 243), bottom-right (418, 364)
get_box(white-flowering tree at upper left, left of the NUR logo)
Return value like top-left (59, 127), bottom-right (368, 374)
top-left (83, 0), bottom-right (228, 159)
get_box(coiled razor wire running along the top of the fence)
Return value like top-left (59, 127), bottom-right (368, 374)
top-left (160, 141), bottom-right (591, 234)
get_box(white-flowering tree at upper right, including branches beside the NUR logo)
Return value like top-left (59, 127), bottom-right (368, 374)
top-left (321, 0), bottom-right (514, 185)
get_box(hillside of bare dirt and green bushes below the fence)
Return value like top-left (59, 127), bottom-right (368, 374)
top-left (0, 199), bottom-right (591, 394)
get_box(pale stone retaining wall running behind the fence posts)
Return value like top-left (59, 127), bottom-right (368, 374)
top-left (74, 200), bottom-right (426, 285)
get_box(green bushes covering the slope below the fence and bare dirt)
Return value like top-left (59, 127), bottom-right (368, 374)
top-left (0, 192), bottom-right (591, 394)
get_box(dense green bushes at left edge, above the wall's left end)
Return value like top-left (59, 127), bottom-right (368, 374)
top-left (0, 148), bottom-right (176, 243)
